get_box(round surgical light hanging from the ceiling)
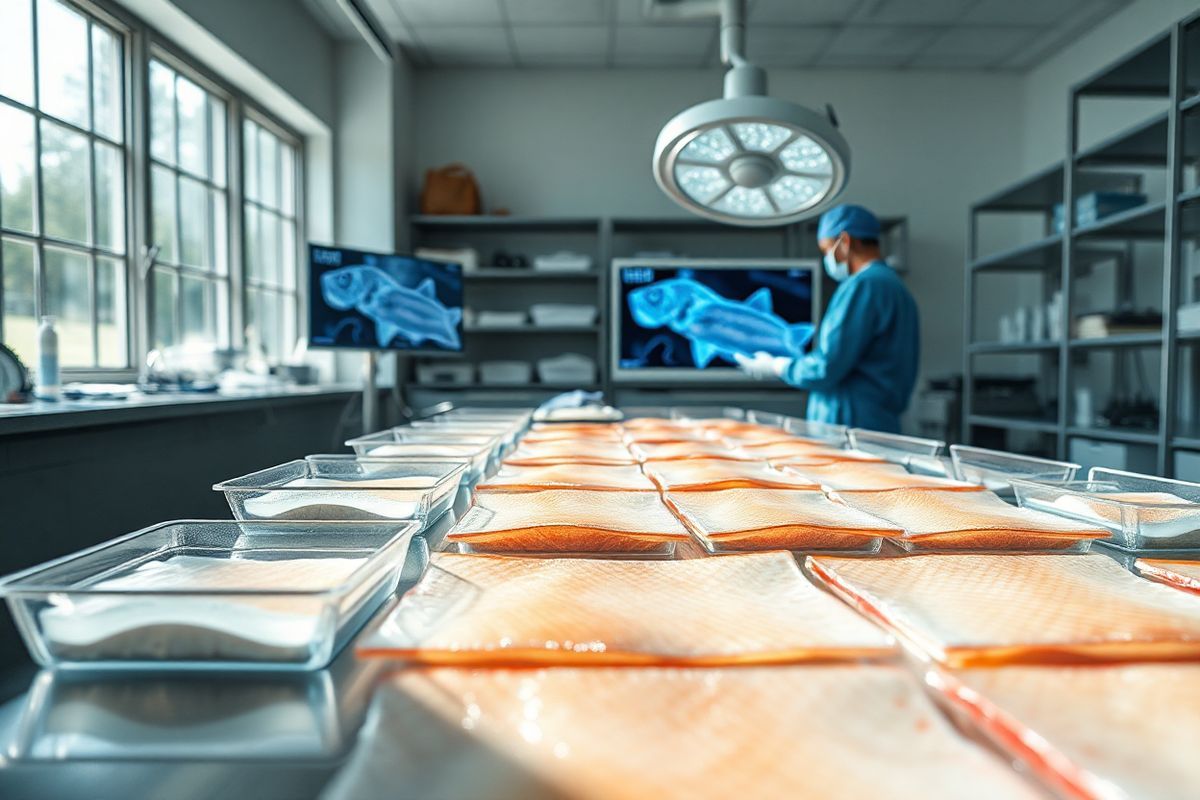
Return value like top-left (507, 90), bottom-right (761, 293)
top-left (654, 0), bottom-right (850, 227)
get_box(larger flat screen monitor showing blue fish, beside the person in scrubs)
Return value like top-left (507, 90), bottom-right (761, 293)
top-left (610, 258), bottom-right (821, 383)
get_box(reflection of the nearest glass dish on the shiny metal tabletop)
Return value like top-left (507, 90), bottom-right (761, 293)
top-left (0, 651), bottom-right (386, 762)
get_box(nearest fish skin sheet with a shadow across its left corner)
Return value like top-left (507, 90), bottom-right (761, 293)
top-left (329, 664), bottom-right (1044, 800)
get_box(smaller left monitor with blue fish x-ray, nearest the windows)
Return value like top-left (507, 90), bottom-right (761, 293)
top-left (308, 245), bottom-right (462, 353)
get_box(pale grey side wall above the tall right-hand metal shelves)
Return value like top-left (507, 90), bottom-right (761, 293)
top-left (1014, 0), bottom-right (1200, 172)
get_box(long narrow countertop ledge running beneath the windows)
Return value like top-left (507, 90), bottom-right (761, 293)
top-left (0, 384), bottom-right (362, 437)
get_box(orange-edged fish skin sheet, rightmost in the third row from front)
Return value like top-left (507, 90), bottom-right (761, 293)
top-left (834, 488), bottom-right (1109, 551)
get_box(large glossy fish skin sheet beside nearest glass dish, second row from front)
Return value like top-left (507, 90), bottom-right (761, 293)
top-left (358, 552), bottom-right (895, 666)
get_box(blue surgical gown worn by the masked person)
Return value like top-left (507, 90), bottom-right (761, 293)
top-left (784, 261), bottom-right (920, 433)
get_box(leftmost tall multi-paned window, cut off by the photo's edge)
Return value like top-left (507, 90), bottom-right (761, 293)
top-left (0, 0), bottom-right (130, 368)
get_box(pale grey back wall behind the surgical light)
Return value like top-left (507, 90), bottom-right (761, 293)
top-left (410, 70), bottom-right (1021, 386)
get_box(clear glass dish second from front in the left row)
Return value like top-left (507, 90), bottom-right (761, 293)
top-left (212, 456), bottom-right (466, 521)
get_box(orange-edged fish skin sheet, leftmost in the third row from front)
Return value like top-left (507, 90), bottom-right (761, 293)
top-left (446, 489), bottom-right (690, 554)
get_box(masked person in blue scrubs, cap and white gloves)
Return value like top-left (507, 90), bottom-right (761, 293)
top-left (738, 205), bottom-right (920, 433)
